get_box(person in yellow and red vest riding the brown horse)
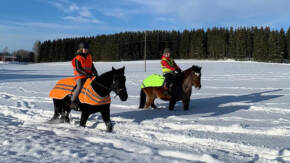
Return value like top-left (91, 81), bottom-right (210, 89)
top-left (161, 48), bottom-right (181, 94)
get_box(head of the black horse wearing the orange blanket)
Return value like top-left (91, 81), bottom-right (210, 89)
top-left (111, 67), bottom-right (128, 101)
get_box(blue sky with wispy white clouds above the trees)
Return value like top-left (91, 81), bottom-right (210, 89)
top-left (0, 0), bottom-right (290, 52)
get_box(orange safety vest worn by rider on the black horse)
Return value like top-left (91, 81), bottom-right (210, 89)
top-left (72, 54), bottom-right (93, 79)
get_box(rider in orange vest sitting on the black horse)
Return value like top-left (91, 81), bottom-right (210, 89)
top-left (70, 42), bottom-right (98, 109)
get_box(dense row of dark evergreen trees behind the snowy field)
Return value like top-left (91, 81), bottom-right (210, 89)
top-left (37, 27), bottom-right (290, 62)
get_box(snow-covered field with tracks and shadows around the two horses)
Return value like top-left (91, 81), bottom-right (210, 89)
top-left (0, 60), bottom-right (290, 163)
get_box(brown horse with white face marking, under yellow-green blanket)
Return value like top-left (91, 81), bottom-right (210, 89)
top-left (139, 65), bottom-right (201, 110)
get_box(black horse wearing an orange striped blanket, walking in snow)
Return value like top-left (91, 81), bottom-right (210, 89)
top-left (49, 67), bottom-right (128, 132)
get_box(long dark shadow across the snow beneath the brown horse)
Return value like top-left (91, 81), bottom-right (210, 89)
top-left (112, 89), bottom-right (283, 123)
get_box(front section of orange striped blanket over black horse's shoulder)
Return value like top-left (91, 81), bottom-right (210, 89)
top-left (79, 78), bottom-right (111, 105)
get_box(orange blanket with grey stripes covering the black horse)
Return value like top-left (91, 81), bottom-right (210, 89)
top-left (49, 77), bottom-right (111, 105)
